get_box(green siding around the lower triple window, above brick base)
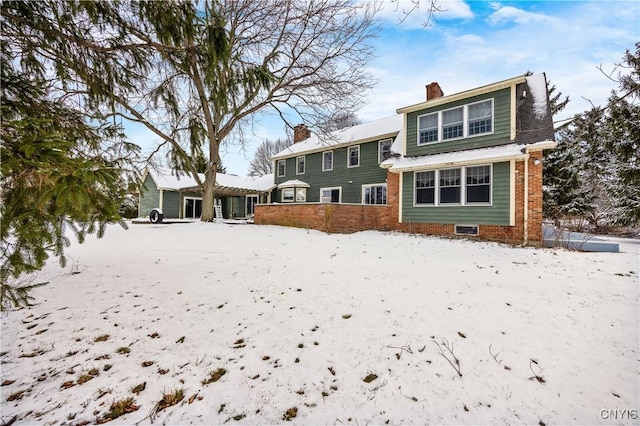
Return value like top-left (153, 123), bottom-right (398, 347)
top-left (402, 162), bottom-right (512, 225)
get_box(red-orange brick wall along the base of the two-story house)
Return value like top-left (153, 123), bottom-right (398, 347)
top-left (254, 160), bottom-right (542, 244)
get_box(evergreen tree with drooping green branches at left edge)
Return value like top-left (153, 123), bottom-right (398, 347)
top-left (0, 1), bottom-right (139, 308)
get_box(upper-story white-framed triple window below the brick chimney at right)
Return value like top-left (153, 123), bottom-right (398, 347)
top-left (418, 99), bottom-right (494, 145)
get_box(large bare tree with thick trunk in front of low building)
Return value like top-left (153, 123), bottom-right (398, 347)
top-left (117, 0), bottom-right (377, 221)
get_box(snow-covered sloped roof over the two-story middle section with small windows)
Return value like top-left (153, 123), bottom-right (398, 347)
top-left (271, 115), bottom-right (403, 160)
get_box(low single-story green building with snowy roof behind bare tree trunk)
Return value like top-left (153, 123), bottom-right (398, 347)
top-left (138, 167), bottom-right (274, 219)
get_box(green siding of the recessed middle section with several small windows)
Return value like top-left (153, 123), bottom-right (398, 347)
top-left (273, 139), bottom-right (387, 204)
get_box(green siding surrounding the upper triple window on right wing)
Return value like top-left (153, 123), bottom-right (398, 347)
top-left (406, 89), bottom-right (511, 157)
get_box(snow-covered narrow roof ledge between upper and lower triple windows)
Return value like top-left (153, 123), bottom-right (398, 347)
top-left (380, 141), bottom-right (556, 172)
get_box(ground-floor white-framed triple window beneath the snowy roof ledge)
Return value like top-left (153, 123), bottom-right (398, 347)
top-left (413, 164), bottom-right (493, 206)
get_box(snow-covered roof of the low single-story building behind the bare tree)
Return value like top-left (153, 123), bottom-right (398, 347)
top-left (143, 167), bottom-right (275, 192)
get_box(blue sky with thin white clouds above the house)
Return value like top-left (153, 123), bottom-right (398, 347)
top-left (130, 0), bottom-right (640, 175)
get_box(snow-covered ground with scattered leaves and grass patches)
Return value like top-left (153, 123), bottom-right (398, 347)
top-left (0, 222), bottom-right (640, 425)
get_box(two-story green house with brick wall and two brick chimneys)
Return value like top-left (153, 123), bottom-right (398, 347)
top-left (255, 73), bottom-right (555, 243)
